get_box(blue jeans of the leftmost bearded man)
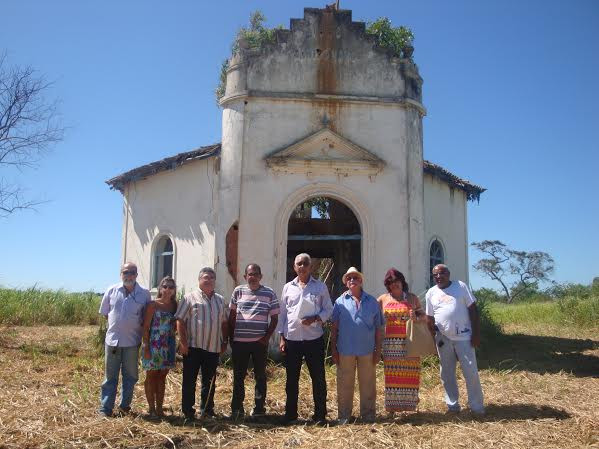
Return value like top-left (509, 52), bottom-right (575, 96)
top-left (100, 345), bottom-right (139, 415)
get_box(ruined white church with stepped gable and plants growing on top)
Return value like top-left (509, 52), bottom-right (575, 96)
top-left (107, 8), bottom-right (484, 297)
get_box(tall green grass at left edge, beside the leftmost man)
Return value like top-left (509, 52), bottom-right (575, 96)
top-left (0, 287), bottom-right (102, 326)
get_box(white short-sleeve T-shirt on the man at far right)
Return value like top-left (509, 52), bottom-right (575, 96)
top-left (426, 281), bottom-right (476, 340)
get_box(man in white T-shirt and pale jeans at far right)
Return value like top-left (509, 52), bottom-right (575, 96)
top-left (426, 264), bottom-right (485, 415)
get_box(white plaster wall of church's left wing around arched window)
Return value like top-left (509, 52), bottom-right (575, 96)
top-left (122, 158), bottom-right (218, 291)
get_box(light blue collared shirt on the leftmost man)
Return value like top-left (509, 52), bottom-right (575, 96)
top-left (99, 282), bottom-right (152, 347)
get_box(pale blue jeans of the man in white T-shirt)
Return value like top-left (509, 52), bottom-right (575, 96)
top-left (436, 332), bottom-right (485, 413)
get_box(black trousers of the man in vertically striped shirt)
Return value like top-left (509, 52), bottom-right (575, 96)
top-left (181, 347), bottom-right (219, 415)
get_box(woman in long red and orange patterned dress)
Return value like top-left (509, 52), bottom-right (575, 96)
top-left (378, 268), bottom-right (426, 415)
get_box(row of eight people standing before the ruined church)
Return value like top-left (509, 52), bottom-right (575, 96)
top-left (100, 253), bottom-right (484, 424)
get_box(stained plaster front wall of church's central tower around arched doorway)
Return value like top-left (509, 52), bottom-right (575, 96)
top-left (217, 9), bottom-right (426, 293)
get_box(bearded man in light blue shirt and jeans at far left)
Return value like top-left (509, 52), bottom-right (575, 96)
top-left (99, 262), bottom-right (152, 416)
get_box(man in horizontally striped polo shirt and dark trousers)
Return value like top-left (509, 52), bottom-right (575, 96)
top-left (229, 263), bottom-right (279, 419)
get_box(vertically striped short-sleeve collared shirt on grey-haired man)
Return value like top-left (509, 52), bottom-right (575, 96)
top-left (175, 290), bottom-right (228, 352)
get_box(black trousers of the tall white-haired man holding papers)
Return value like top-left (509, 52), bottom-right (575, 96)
top-left (285, 337), bottom-right (327, 421)
